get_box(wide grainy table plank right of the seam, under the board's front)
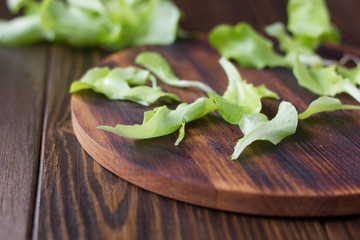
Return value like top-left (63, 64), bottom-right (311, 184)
top-left (32, 46), bottom-right (327, 240)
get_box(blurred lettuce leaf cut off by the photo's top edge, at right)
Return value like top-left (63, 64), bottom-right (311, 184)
top-left (287, 0), bottom-right (340, 49)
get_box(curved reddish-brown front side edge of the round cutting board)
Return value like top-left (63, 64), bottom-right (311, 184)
top-left (71, 95), bottom-right (360, 217)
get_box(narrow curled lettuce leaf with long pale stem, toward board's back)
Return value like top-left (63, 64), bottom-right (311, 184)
top-left (135, 51), bottom-right (213, 92)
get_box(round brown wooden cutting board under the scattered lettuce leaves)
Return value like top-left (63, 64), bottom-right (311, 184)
top-left (71, 38), bottom-right (360, 216)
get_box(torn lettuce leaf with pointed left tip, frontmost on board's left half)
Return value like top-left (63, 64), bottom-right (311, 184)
top-left (98, 97), bottom-right (216, 145)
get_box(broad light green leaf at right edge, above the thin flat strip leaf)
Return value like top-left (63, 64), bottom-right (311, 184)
top-left (293, 57), bottom-right (360, 102)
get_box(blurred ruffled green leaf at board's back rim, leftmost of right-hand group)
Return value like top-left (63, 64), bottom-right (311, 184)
top-left (209, 22), bottom-right (290, 69)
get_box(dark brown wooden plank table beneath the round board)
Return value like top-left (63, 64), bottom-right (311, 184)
top-left (0, 0), bottom-right (360, 240)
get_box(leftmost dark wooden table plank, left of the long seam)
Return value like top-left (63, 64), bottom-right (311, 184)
top-left (0, 46), bottom-right (47, 239)
